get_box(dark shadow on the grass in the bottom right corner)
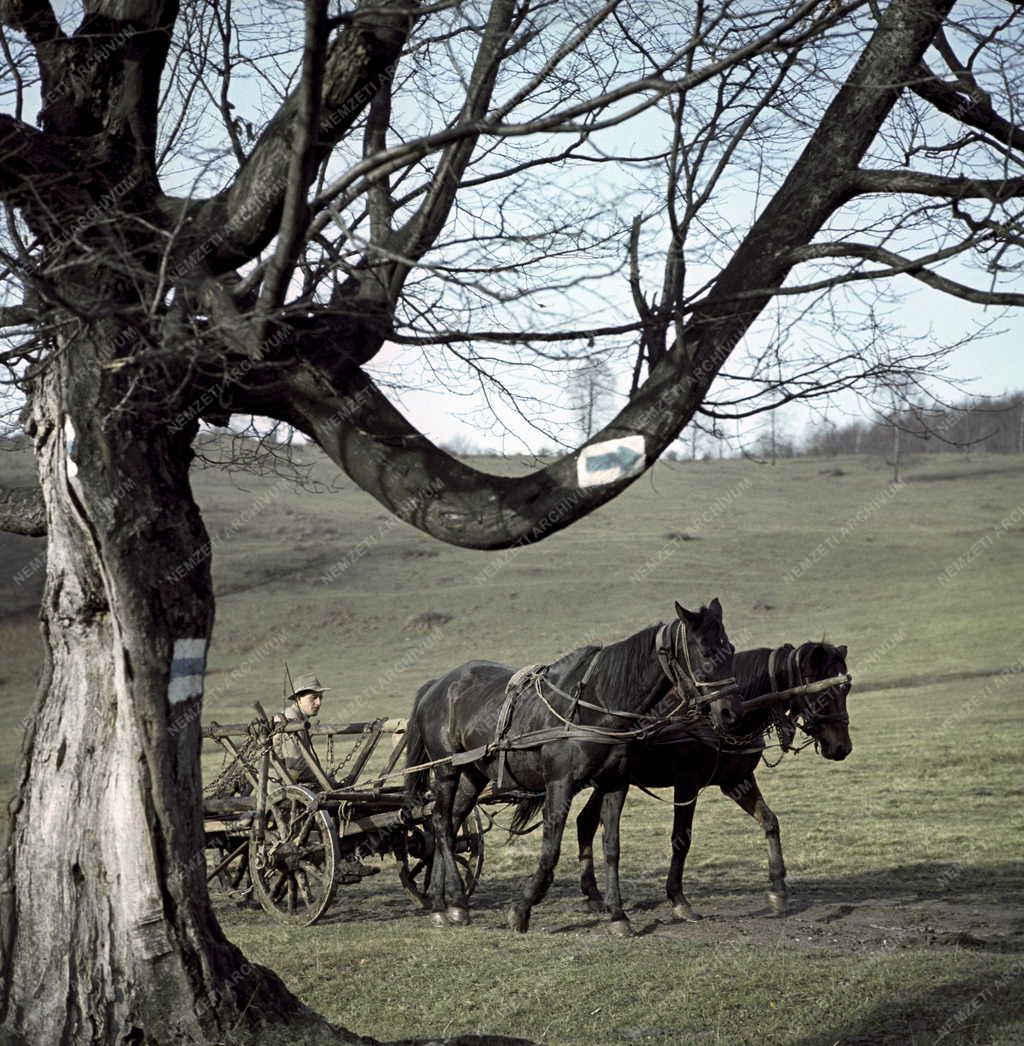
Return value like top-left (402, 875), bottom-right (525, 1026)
top-left (793, 961), bottom-right (1024, 1046)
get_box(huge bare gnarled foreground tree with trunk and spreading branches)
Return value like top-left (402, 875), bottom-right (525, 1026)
top-left (0, 0), bottom-right (1024, 1043)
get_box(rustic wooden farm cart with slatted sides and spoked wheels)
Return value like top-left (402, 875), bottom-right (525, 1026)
top-left (203, 704), bottom-right (485, 926)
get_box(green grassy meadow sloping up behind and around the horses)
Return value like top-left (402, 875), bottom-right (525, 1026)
top-left (0, 451), bottom-right (1024, 1046)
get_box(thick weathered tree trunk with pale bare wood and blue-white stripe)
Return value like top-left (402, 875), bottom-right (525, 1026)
top-left (0, 332), bottom-right (299, 1046)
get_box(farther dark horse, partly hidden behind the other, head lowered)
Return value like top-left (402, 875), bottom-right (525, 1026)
top-left (576, 642), bottom-right (854, 920)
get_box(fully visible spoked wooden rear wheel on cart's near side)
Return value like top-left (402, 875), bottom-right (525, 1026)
top-left (249, 785), bottom-right (339, 926)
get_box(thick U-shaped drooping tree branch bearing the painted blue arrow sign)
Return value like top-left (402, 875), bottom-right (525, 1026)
top-left (252, 0), bottom-right (953, 548)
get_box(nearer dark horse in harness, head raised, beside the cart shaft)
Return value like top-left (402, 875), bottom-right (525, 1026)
top-left (407, 599), bottom-right (735, 932)
